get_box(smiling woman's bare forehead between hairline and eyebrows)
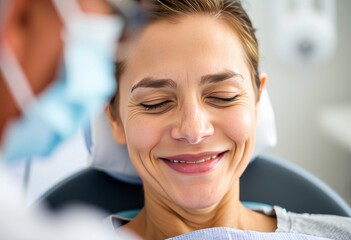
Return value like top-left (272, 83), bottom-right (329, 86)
top-left (122, 15), bottom-right (247, 82)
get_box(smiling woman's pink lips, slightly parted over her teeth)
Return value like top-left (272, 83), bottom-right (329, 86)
top-left (160, 152), bottom-right (225, 174)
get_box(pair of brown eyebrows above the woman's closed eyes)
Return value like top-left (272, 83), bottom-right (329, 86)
top-left (131, 70), bottom-right (244, 92)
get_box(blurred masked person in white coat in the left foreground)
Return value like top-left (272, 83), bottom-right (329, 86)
top-left (0, 0), bottom-right (143, 240)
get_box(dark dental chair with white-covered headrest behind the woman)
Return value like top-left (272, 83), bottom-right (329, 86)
top-left (39, 92), bottom-right (351, 217)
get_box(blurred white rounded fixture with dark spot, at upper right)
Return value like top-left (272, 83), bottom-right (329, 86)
top-left (273, 0), bottom-right (337, 65)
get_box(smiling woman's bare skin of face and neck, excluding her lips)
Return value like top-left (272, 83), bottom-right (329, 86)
top-left (106, 15), bottom-right (276, 239)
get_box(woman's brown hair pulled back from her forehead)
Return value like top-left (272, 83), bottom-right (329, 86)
top-left (110, 0), bottom-right (260, 116)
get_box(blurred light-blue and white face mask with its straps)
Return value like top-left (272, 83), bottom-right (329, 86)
top-left (0, 0), bottom-right (123, 160)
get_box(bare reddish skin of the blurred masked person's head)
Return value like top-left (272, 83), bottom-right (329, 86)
top-left (0, 0), bottom-right (112, 142)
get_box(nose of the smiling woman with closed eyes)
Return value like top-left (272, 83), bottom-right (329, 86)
top-left (171, 101), bottom-right (214, 144)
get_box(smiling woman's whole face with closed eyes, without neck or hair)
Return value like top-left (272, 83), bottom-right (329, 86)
top-left (112, 15), bottom-right (256, 209)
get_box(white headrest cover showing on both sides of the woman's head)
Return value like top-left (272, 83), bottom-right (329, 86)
top-left (85, 90), bottom-right (277, 183)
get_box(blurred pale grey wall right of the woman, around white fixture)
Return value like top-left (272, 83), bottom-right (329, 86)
top-left (245, 0), bottom-right (351, 204)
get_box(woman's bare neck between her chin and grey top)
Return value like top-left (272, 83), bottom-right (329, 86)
top-left (126, 182), bottom-right (276, 239)
